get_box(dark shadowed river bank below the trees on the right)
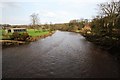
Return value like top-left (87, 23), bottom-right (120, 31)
top-left (82, 34), bottom-right (120, 61)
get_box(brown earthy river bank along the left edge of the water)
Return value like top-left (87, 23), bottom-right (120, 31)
top-left (0, 31), bottom-right (55, 48)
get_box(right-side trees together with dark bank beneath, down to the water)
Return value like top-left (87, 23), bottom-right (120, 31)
top-left (82, 1), bottom-right (120, 59)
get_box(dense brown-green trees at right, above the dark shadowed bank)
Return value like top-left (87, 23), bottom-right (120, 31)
top-left (91, 1), bottom-right (120, 35)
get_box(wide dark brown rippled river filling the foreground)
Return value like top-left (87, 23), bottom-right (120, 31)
top-left (2, 31), bottom-right (120, 78)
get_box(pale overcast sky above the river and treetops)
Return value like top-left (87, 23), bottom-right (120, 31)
top-left (0, 0), bottom-right (110, 24)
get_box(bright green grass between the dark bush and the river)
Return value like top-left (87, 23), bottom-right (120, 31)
top-left (27, 29), bottom-right (49, 37)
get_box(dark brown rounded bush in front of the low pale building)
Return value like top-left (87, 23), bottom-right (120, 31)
top-left (10, 32), bottom-right (30, 41)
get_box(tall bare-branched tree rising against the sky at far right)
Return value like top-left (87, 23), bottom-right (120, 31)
top-left (99, 1), bottom-right (120, 34)
